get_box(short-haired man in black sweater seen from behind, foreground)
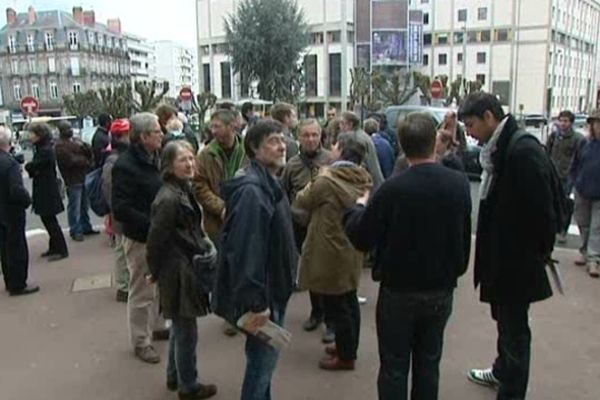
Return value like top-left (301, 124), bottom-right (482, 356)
top-left (345, 113), bottom-right (471, 400)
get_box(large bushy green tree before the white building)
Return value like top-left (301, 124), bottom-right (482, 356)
top-left (224, 0), bottom-right (309, 101)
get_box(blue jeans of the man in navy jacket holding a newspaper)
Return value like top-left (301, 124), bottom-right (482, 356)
top-left (242, 303), bottom-right (287, 400)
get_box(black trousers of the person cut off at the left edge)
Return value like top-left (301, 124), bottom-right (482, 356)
top-left (0, 211), bottom-right (29, 292)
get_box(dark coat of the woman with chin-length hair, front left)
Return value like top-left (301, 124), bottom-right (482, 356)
top-left (146, 179), bottom-right (212, 318)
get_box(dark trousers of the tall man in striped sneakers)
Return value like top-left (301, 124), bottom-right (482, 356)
top-left (492, 304), bottom-right (531, 400)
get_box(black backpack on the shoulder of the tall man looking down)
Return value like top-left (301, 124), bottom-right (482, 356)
top-left (505, 131), bottom-right (573, 234)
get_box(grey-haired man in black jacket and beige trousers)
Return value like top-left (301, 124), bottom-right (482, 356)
top-left (112, 113), bottom-right (168, 363)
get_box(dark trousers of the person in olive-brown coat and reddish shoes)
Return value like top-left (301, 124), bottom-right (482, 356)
top-left (323, 290), bottom-right (360, 360)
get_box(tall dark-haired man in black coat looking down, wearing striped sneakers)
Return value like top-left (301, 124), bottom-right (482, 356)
top-left (460, 93), bottom-right (557, 400)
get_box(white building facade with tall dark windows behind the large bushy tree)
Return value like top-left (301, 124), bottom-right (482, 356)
top-left (196, 0), bottom-right (355, 115)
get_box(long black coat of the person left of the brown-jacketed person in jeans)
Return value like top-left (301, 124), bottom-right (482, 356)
top-left (25, 138), bottom-right (65, 216)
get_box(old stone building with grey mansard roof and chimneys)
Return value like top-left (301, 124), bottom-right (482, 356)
top-left (0, 7), bottom-right (131, 115)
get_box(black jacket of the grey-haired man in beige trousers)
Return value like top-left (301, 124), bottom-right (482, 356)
top-left (111, 143), bottom-right (162, 243)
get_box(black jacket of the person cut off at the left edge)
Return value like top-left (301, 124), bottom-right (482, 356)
top-left (0, 150), bottom-right (31, 225)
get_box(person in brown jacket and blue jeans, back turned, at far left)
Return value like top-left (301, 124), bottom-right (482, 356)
top-left (54, 122), bottom-right (99, 242)
